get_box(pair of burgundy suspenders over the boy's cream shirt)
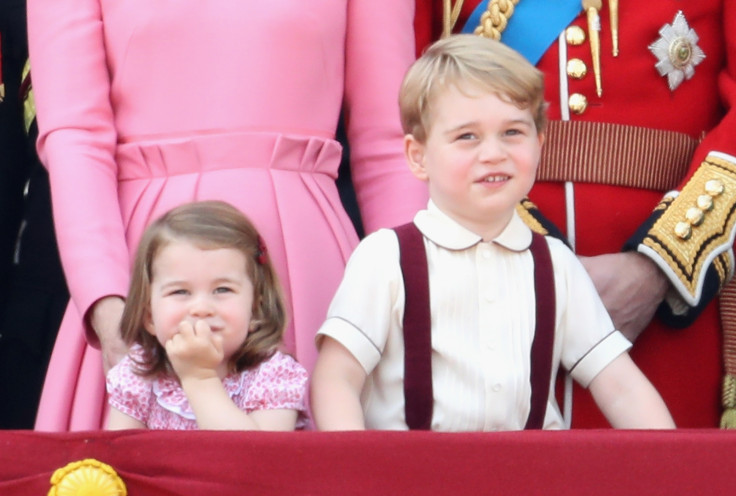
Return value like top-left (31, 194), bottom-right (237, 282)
top-left (394, 223), bottom-right (556, 430)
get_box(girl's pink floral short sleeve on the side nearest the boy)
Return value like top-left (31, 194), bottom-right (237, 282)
top-left (239, 353), bottom-right (307, 413)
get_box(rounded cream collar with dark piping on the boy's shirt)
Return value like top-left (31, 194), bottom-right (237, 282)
top-left (414, 200), bottom-right (532, 251)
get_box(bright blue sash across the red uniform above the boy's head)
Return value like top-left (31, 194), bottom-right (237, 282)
top-left (462, 0), bottom-right (582, 65)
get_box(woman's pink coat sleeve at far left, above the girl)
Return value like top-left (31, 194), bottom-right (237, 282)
top-left (28, 0), bottom-right (129, 340)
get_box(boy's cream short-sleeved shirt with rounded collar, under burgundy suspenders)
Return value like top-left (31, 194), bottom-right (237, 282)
top-left (318, 201), bottom-right (631, 431)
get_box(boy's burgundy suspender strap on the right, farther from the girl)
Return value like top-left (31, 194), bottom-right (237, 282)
top-left (524, 232), bottom-right (557, 429)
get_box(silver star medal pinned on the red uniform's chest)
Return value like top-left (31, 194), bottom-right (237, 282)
top-left (649, 11), bottom-right (705, 91)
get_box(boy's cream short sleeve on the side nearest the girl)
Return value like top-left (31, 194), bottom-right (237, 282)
top-left (316, 229), bottom-right (404, 374)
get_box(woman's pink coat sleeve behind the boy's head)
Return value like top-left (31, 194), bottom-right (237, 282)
top-left (345, 0), bottom-right (428, 233)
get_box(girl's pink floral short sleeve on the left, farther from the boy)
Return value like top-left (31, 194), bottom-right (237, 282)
top-left (106, 356), bottom-right (151, 424)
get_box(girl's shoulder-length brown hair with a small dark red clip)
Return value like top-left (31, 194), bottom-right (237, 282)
top-left (120, 201), bottom-right (286, 376)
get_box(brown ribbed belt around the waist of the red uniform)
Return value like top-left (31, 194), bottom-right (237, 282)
top-left (537, 121), bottom-right (699, 191)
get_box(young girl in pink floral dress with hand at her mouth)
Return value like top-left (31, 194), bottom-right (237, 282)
top-left (107, 201), bottom-right (307, 430)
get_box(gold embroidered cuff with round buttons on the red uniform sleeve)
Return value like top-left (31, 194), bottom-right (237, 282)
top-left (638, 152), bottom-right (736, 306)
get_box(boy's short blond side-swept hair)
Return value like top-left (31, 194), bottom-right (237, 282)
top-left (399, 34), bottom-right (547, 143)
